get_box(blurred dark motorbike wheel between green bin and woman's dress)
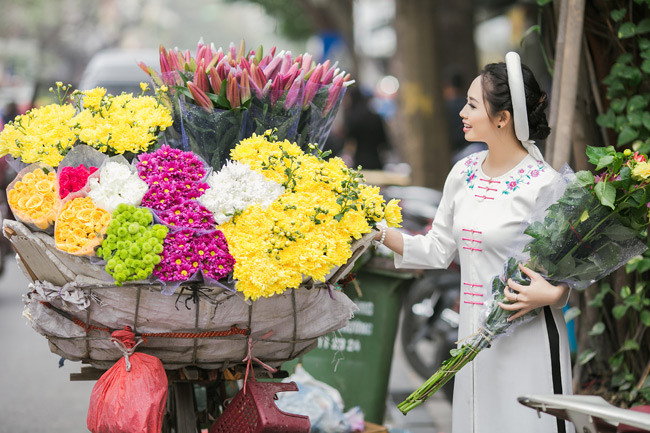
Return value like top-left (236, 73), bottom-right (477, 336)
top-left (401, 271), bottom-right (458, 402)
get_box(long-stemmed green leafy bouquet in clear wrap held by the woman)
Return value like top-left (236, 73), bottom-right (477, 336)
top-left (398, 147), bottom-right (650, 414)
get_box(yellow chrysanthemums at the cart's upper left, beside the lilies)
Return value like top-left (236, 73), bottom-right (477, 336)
top-left (0, 82), bottom-right (172, 167)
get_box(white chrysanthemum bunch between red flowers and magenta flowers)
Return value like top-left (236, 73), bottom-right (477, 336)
top-left (88, 161), bottom-right (148, 213)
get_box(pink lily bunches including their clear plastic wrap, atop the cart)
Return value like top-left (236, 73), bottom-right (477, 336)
top-left (141, 41), bottom-right (353, 170)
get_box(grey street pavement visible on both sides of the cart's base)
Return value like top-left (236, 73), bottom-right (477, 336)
top-left (0, 257), bottom-right (451, 433)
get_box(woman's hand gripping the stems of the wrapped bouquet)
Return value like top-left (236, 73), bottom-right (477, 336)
top-left (499, 263), bottom-right (569, 321)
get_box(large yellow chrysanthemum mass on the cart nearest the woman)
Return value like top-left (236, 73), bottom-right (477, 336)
top-left (219, 133), bottom-right (401, 299)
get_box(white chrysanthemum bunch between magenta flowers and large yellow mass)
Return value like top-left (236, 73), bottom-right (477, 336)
top-left (198, 161), bottom-right (284, 224)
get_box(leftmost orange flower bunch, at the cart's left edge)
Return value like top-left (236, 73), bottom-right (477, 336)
top-left (7, 168), bottom-right (59, 230)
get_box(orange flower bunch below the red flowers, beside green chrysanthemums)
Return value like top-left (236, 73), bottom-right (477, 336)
top-left (54, 197), bottom-right (111, 255)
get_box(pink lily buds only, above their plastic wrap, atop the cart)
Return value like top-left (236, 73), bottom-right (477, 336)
top-left (140, 40), bottom-right (354, 116)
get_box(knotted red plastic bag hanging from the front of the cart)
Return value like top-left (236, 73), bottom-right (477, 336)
top-left (86, 327), bottom-right (167, 433)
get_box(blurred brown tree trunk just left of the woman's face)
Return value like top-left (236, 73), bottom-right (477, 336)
top-left (395, 0), bottom-right (450, 189)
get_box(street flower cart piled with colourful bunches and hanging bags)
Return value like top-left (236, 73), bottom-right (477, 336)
top-left (0, 43), bottom-right (401, 432)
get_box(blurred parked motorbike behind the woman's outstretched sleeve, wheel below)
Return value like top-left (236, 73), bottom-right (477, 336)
top-left (383, 186), bottom-right (460, 401)
